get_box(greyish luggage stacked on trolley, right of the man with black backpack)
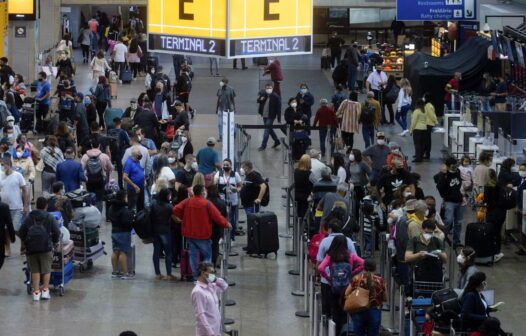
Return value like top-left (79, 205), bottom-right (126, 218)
top-left (66, 189), bottom-right (105, 272)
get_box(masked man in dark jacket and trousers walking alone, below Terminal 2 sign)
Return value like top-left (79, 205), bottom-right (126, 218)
top-left (257, 83), bottom-right (281, 151)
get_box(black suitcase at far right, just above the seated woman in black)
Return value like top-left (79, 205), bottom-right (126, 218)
top-left (465, 222), bottom-right (497, 264)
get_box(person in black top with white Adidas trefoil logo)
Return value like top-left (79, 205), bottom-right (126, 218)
top-left (380, 158), bottom-right (415, 210)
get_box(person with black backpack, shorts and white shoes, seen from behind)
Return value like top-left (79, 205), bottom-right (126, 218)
top-left (17, 195), bottom-right (60, 301)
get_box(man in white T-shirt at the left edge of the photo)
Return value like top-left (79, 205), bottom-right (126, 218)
top-left (0, 157), bottom-right (29, 255)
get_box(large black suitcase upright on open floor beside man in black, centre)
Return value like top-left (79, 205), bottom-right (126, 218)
top-left (247, 211), bottom-right (279, 257)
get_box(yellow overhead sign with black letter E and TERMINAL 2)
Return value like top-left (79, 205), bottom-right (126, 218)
top-left (148, 0), bottom-right (312, 58)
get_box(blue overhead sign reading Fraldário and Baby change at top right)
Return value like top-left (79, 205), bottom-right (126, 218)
top-left (396, 0), bottom-right (477, 21)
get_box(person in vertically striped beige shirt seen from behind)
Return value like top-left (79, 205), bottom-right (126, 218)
top-left (336, 91), bottom-right (362, 149)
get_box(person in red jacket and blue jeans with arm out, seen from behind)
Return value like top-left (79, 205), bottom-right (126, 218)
top-left (172, 184), bottom-right (232, 281)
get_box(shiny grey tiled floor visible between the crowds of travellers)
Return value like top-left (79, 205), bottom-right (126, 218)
top-left (0, 48), bottom-right (526, 336)
